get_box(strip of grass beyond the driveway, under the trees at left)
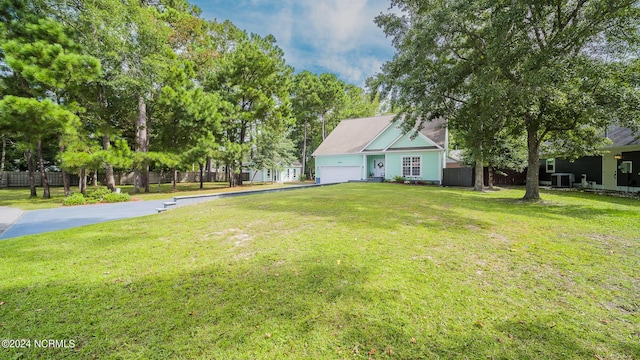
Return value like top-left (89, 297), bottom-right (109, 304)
top-left (0, 182), bottom-right (302, 210)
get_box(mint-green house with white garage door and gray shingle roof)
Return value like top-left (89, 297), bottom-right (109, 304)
top-left (312, 115), bottom-right (447, 184)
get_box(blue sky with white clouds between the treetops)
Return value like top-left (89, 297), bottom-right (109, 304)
top-left (190, 0), bottom-right (394, 86)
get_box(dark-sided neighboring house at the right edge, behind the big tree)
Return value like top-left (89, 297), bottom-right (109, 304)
top-left (540, 126), bottom-right (640, 192)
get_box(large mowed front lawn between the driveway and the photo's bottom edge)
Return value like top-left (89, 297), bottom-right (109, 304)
top-left (0, 184), bottom-right (640, 359)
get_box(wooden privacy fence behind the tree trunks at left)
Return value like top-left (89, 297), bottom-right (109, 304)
top-left (0, 171), bottom-right (224, 188)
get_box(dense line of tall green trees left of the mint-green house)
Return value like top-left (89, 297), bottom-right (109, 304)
top-left (0, 0), bottom-right (378, 198)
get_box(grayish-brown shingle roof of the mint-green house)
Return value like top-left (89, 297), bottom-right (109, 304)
top-left (313, 115), bottom-right (447, 156)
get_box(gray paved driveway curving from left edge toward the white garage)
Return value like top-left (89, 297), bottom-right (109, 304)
top-left (0, 185), bottom-right (330, 240)
